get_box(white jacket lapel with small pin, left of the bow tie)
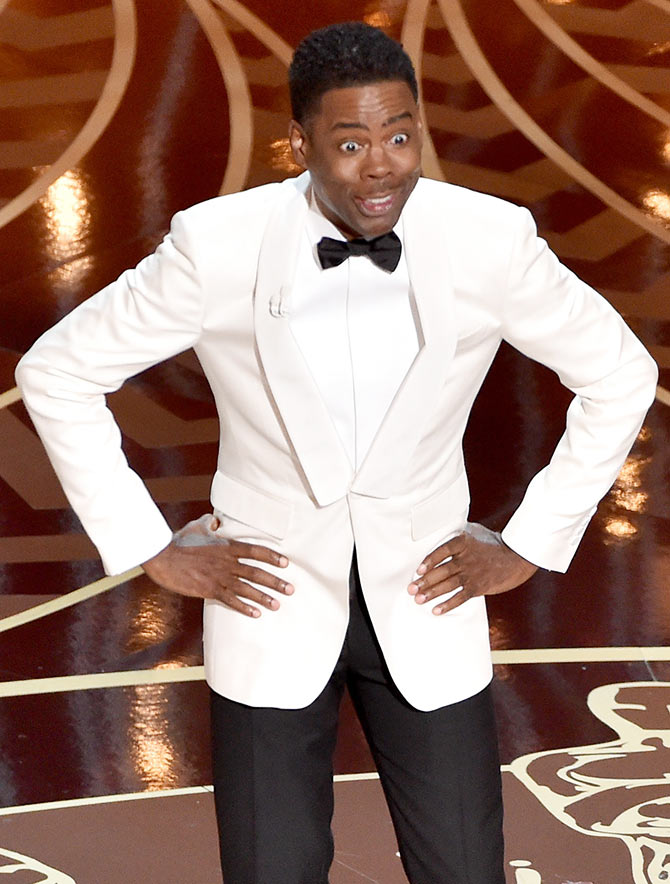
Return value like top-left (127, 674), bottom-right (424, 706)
top-left (254, 175), bottom-right (353, 506)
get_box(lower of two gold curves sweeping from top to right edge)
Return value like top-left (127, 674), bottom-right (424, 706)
top-left (437, 0), bottom-right (670, 243)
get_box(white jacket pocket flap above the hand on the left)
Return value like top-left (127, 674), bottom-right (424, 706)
top-left (212, 471), bottom-right (293, 540)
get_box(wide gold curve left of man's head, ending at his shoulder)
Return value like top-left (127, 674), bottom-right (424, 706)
top-left (186, 0), bottom-right (254, 193)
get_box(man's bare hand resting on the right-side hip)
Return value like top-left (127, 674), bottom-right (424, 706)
top-left (408, 524), bottom-right (537, 615)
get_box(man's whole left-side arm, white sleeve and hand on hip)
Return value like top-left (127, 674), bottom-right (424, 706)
top-left (17, 215), bottom-right (292, 616)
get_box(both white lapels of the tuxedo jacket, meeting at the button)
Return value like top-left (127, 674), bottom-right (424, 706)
top-left (254, 175), bottom-right (456, 506)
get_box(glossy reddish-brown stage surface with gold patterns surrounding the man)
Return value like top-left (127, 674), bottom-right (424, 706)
top-left (0, 0), bottom-right (670, 884)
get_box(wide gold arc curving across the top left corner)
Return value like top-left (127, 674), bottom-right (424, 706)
top-left (0, 0), bottom-right (137, 227)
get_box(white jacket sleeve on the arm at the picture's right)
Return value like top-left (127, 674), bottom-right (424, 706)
top-left (502, 209), bottom-right (658, 571)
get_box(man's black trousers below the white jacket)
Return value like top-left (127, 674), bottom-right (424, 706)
top-left (212, 560), bottom-right (505, 884)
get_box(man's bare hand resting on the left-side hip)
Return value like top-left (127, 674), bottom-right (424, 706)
top-left (142, 515), bottom-right (294, 617)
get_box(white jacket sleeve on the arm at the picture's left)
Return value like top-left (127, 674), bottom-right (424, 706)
top-left (16, 215), bottom-right (203, 574)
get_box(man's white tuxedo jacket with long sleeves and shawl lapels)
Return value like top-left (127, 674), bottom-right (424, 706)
top-left (17, 175), bottom-right (656, 710)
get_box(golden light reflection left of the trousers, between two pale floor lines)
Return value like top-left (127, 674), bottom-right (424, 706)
top-left (128, 684), bottom-right (178, 791)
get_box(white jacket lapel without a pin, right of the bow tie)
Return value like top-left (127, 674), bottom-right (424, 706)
top-left (351, 182), bottom-right (456, 497)
